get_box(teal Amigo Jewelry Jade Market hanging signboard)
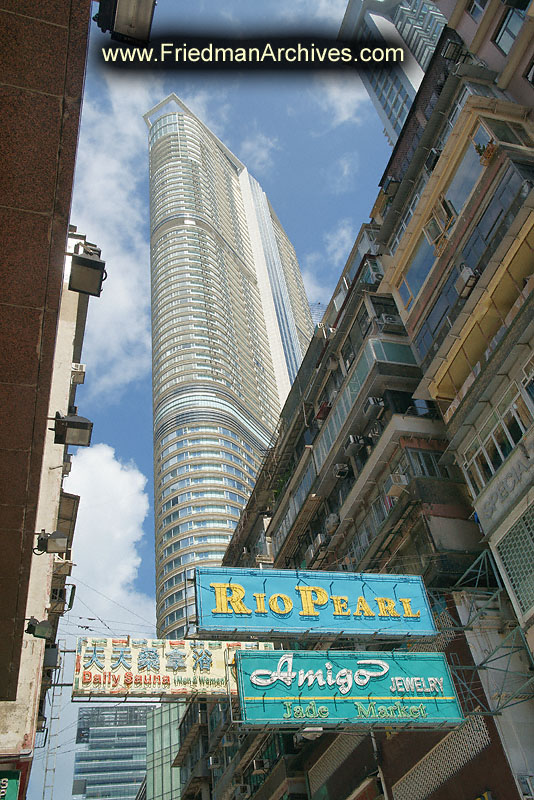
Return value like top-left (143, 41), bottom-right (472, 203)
top-left (236, 650), bottom-right (463, 728)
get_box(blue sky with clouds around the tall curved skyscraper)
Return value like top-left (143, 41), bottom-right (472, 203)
top-left (28, 0), bottom-right (390, 800)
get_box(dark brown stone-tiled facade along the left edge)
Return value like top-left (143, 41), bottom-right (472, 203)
top-left (0, 0), bottom-right (91, 701)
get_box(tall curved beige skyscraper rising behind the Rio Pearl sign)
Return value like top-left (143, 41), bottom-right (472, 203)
top-left (145, 95), bottom-right (312, 638)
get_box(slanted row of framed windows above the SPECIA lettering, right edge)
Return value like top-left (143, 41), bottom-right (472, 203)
top-left (463, 382), bottom-right (533, 497)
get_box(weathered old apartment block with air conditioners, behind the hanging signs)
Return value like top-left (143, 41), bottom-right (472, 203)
top-left (165, 3), bottom-right (534, 800)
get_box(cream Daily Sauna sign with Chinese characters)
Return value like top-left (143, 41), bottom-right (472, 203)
top-left (72, 636), bottom-right (272, 697)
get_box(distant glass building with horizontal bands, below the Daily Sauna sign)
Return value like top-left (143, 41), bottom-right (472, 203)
top-left (72, 704), bottom-right (150, 800)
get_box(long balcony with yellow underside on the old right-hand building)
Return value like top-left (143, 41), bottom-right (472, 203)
top-left (417, 170), bottom-right (534, 406)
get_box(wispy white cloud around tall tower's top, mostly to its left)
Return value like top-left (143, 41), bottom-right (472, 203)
top-left (72, 73), bottom-right (228, 401)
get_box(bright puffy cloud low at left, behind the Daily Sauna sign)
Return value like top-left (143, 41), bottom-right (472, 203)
top-left (28, 444), bottom-right (155, 800)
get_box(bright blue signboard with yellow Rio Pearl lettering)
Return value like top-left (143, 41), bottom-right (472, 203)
top-left (195, 567), bottom-right (436, 639)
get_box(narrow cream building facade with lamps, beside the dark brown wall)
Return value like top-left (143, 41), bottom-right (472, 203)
top-left (0, 226), bottom-right (103, 798)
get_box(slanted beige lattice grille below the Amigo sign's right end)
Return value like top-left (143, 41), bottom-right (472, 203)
top-left (393, 717), bottom-right (490, 800)
